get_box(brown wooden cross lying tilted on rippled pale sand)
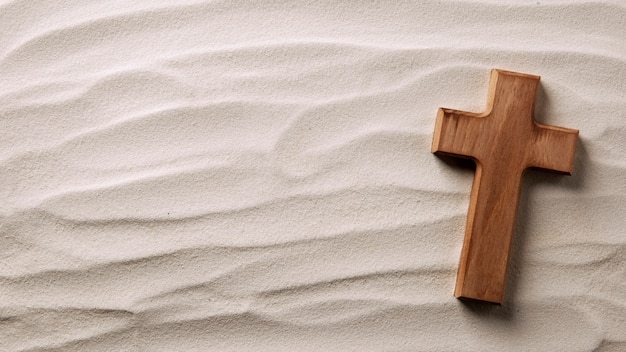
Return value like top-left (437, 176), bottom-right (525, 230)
top-left (432, 70), bottom-right (578, 304)
